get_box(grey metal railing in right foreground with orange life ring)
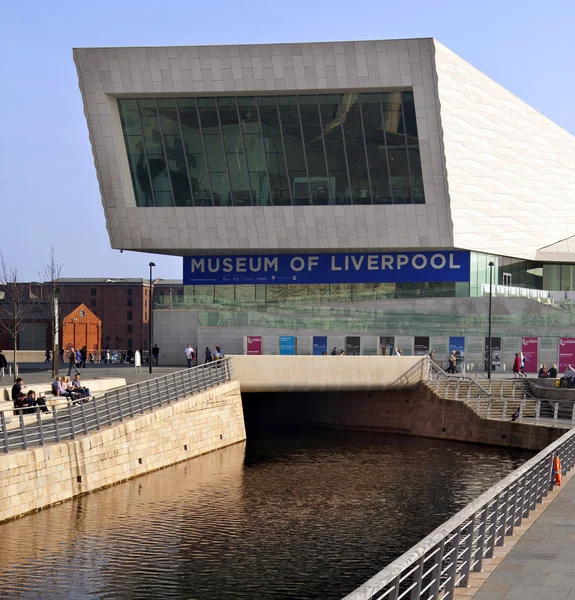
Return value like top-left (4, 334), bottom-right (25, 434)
top-left (344, 430), bottom-right (575, 600)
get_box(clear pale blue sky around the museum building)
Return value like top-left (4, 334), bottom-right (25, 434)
top-left (0, 0), bottom-right (575, 279)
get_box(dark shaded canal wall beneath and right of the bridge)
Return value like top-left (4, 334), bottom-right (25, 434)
top-left (248, 385), bottom-right (565, 450)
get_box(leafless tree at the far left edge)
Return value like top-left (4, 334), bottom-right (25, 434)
top-left (0, 252), bottom-right (31, 380)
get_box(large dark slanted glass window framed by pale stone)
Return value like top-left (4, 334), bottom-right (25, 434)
top-left (118, 91), bottom-right (425, 206)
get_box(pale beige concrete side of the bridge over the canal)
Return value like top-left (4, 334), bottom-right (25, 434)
top-left (232, 356), bottom-right (424, 392)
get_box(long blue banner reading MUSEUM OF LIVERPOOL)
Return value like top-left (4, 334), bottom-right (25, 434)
top-left (184, 250), bottom-right (470, 285)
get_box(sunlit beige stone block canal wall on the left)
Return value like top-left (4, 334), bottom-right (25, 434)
top-left (0, 382), bottom-right (246, 522)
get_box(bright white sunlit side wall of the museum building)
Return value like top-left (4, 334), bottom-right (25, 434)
top-left (433, 40), bottom-right (575, 259)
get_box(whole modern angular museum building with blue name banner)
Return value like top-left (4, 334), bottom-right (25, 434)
top-left (74, 39), bottom-right (575, 371)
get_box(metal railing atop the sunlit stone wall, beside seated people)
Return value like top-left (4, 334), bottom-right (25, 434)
top-left (0, 358), bottom-right (232, 453)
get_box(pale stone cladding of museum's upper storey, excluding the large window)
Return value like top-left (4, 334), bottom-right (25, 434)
top-left (74, 39), bottom-right (575, 258)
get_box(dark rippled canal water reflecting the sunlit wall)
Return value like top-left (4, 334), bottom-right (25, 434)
top-left (0, 429), bottom-right (528, 600)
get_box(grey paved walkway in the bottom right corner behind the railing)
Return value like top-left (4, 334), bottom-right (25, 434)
top-left (462, 471), bottom-right (575, 600)
